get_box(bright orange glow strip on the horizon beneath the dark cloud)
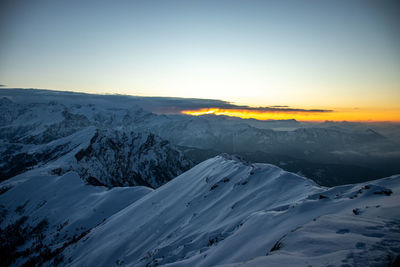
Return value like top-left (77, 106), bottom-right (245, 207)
top-left (181, 108), bottom-right (400, 122)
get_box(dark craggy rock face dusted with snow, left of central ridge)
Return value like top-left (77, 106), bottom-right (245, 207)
top-left (74, 130), bottom-right (192, 188)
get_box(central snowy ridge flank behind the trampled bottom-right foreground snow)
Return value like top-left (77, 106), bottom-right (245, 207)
top-left (67, 156), bottom-right (399, 266)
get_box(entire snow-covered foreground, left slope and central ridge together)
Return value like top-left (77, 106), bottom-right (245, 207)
top-left (0, 154), bottom-right (400, 266)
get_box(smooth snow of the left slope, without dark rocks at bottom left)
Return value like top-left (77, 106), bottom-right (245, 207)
top-left (0, 169), bottom-right (152, 266)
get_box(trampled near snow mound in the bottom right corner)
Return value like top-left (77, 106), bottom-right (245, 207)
top-left (223, 214), bottom-right (400, 267)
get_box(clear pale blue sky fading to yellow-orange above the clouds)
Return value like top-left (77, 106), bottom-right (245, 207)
top-left (0, 0), bottom-right (400, 121)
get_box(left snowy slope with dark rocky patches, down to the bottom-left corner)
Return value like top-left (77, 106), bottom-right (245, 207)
top-left (0, 169), bottom-right (152, 266)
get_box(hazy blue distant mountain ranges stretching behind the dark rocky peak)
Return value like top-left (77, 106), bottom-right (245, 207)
top-left (0, 89), bottom-right (400, 187)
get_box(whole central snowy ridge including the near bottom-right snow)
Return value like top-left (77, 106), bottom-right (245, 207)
top-left (57, 155), bottom-right (400, 266)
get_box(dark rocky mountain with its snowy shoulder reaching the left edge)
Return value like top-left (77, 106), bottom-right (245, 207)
top-left (0, 126), bottom-right (192, 188)
